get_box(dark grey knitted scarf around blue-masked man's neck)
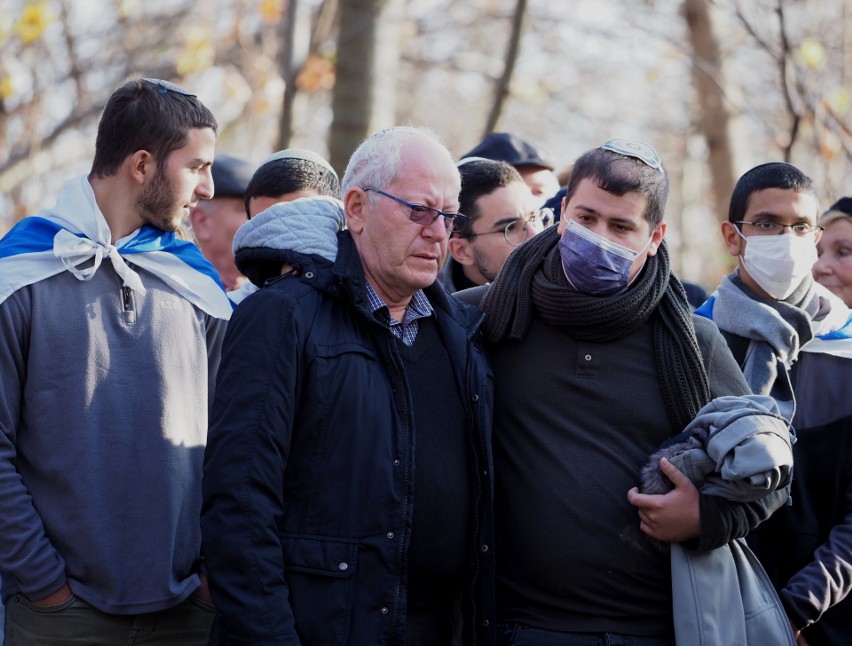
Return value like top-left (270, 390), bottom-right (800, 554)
top-left (482, 227), bottom-right (710, 431)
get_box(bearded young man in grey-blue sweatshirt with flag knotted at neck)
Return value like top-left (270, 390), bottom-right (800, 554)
top-left (0, 79), bottom-right (231, 646)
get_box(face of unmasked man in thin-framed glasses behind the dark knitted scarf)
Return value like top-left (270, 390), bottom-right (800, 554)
top-left (450, 182), bottom-right (540, 285)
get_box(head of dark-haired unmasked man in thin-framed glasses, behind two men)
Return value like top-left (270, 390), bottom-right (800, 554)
top-left (440, 157), bottom-right (542, 292)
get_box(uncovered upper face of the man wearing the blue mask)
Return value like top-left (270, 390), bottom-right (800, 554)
top-left (559, 178), bottom-right (666, 280)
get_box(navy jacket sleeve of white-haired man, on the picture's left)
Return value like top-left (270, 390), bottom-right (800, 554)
top-left (201, 288), bottom-right (304, 646)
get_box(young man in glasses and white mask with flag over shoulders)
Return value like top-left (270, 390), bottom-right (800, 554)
top-left (697, 162), bottom-right (852, 646)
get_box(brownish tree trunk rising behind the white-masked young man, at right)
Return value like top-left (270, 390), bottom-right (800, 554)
top-left (683, 0), bottom-right (734, 222)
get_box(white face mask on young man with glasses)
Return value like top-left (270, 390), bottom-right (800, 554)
top-left (737, 230), bottom-right (817, 300)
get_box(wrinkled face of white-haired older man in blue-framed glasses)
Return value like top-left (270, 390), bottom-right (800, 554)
top-left (344, 139), bottom-right (461, 305)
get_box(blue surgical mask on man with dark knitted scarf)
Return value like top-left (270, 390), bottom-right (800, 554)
top-left (559, 220), bottom-right (651, 296)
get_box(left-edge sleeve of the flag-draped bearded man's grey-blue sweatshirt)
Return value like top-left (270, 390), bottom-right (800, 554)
top-left (0, 288), bottom-right (66, 600)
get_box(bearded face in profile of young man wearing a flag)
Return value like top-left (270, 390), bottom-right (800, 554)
top-left (136, 128), bottom-right (216, 231)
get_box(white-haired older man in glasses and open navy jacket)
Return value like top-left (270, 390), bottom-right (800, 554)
top-left (202, 127), bottom-right (494, 646)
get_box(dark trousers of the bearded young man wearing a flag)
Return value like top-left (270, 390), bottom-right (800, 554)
top-left (5, 594), bottom-right (216, 646)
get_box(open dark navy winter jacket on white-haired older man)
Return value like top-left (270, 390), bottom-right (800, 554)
top-left (202, 232), bottom-right (494, 646)
